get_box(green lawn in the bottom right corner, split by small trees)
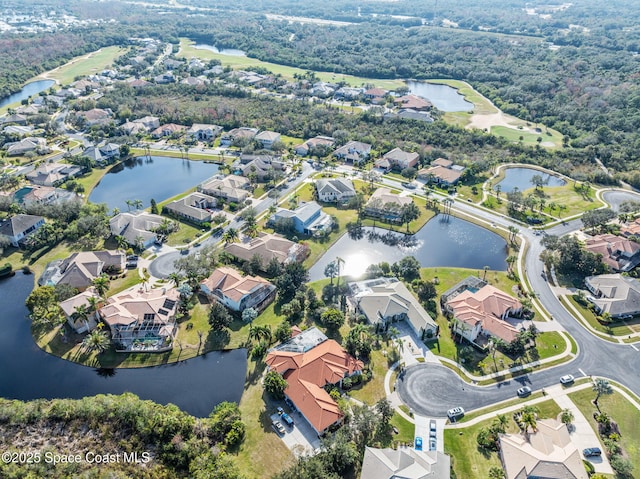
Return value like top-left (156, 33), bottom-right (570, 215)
top-left (569, 389), bottom-right (640, 470)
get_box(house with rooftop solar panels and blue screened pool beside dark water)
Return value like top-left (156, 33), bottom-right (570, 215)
top-left (98, 288), bottom-right (180, 352)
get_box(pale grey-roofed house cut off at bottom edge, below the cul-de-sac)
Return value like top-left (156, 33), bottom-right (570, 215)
top-left (360, 446), bottom-right (451, 479)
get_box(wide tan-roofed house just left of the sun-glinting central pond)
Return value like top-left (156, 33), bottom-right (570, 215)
top-left (224, 232), bottom-right (309, 268)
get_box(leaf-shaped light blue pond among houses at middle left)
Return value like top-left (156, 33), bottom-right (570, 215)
top-left (89, 156), bottom-right (218, 211)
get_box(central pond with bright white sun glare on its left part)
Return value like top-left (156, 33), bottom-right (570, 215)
top-left (309, 215), bottom-right (507, 281)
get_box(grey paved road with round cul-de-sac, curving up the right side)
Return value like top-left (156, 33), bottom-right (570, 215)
top-left (398, 191), bottom-right (640, 417)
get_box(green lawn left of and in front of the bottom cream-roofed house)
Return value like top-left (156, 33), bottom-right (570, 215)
top-left (444, 399), bottom-right (560, 478)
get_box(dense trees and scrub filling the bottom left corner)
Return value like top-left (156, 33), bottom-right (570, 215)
top-left (0, 393), bottom-right (245, 479)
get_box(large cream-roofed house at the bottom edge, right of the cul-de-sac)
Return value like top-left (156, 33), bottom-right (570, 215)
top-left (499, 419), bottom-right (589, 479)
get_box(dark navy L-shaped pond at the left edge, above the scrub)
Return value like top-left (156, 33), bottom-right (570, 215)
top-left (0, 273), bottom-right (247, 417)
